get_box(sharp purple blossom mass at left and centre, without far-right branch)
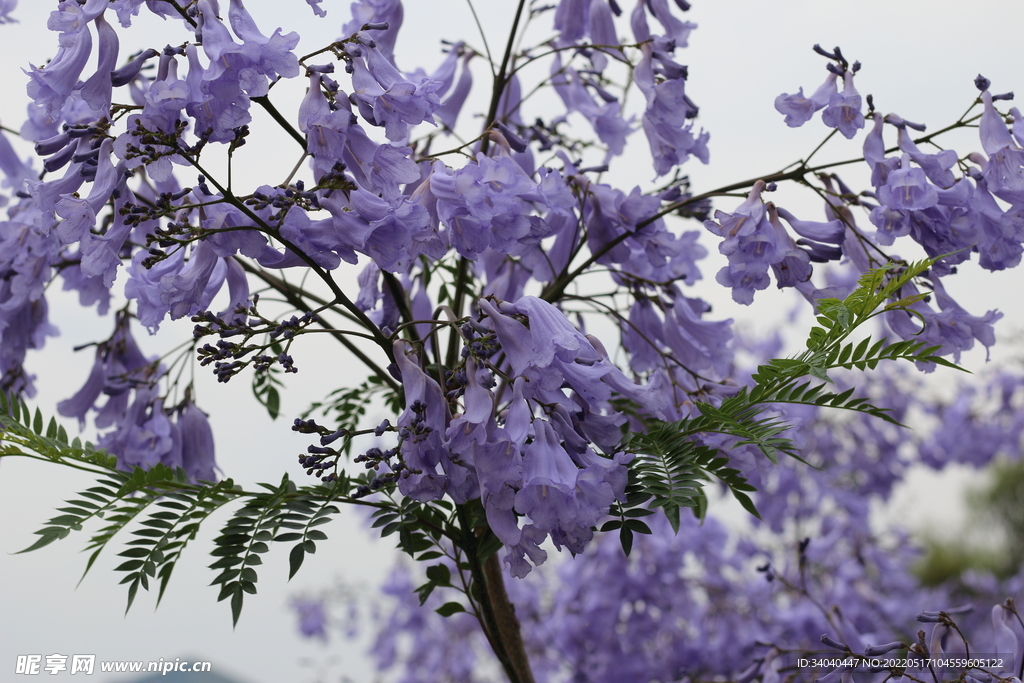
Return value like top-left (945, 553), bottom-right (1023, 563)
top-left (0, 0), bottom-right (728, 532)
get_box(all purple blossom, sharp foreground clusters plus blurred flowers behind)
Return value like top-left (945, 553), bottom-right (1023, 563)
top-left (0, 5), bottom-right (1024, 681)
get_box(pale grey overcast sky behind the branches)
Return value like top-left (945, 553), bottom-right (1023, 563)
top-left (0, 0), bottom-right (1024, 683)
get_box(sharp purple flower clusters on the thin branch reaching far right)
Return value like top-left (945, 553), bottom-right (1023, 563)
top-left (705, 46), bottom-right (1024, 368)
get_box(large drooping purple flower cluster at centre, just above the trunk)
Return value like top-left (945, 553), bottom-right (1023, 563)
top-left (466, 297), bottom-right (666, 575)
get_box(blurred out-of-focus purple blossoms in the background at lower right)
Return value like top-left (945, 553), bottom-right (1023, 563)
top-left (335, 362), bottom-right (1024, 682)
